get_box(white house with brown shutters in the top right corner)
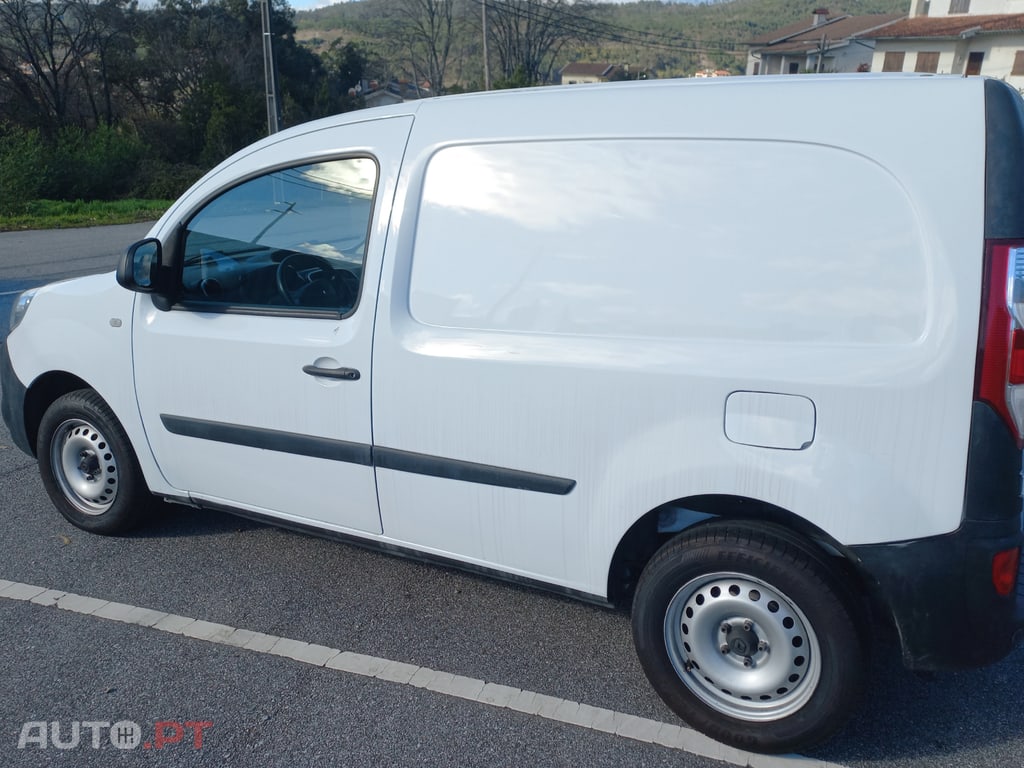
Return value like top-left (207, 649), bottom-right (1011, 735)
top-left (865, 0), bottom-right (1024, 90)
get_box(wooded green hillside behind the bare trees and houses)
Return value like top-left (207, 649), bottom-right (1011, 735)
top-left (296, 0), bottom-right (908, 83)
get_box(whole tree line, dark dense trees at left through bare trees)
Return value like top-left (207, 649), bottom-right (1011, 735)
top-left (0, 0), bottom-right (618, 213)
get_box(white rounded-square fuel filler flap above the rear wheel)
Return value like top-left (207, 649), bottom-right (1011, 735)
top-left (725, 392), bottom-right (814, 451)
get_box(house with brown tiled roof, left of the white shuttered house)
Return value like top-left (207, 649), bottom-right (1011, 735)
top-left (746, 8), bottom-right (905, 75)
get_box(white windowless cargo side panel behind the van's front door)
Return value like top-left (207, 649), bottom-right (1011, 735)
top-left (373, 79), bottom-right (984, 595)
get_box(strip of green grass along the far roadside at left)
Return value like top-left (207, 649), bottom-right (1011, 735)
top-left (0, 200), bottom-right (172, 231)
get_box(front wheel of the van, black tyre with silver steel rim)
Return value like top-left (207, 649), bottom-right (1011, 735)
top-left (36, 389), bottom-right (153, 535)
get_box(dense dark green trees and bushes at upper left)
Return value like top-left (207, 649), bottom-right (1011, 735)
top-left (0, 0), bottom-right (366, 213)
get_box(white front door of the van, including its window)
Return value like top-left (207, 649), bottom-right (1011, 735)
top-left (133, 120), bottom-right (409, 534)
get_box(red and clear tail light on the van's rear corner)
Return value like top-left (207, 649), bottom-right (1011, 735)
top-left (975, 243), bottom-right (1024, 446)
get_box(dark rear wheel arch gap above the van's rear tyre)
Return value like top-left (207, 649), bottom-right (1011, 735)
top-left (607, 494), bottom-right (871, 607)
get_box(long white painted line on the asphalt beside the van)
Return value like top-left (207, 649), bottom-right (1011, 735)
top-left (0, 579), bottom-right (842, 768)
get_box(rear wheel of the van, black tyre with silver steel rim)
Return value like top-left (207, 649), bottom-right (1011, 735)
top-left (633, 521), bottom-right (868, 753)
